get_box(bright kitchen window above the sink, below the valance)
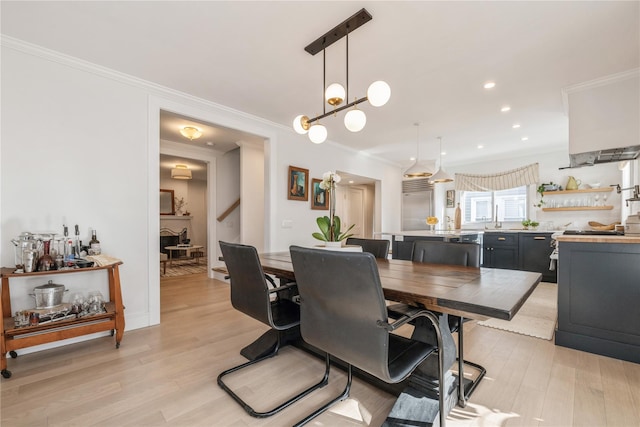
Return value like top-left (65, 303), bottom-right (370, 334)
top-left (462, 185), bottom-right (527, 224)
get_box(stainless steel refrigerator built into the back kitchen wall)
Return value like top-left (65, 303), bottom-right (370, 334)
top-left (402, 178), bottom-right (434, 231)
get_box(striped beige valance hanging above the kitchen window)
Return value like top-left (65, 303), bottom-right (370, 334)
top-left (455, 163), bottom-right (539, 191)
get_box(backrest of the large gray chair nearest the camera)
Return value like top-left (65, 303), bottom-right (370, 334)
top-left (290, 246), bottom-right (395, 382)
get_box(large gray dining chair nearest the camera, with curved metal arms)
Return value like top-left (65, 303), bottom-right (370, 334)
top-left (290, 246), bottom-right (445, 426)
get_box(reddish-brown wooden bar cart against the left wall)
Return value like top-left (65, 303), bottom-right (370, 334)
top-left (0, 262), bottom-right (124, 378)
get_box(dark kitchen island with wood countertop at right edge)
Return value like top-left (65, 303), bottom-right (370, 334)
top-left (555, 235), bottom-right (640, 363)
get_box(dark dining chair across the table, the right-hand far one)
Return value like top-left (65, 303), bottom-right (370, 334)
top-left (388, 240), bottom-right (487, 407)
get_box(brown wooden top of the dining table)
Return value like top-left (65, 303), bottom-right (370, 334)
top-left (260, 252), bottom-right (542, 320)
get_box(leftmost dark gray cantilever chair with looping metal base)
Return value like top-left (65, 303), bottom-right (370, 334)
top-left (218, 241), bottom-right (328, 418)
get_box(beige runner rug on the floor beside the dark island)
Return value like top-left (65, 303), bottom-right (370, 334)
top-left (478, 282), bottom-right (558, 340)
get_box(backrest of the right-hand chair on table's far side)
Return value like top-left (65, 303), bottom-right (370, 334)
top-left (411, 240), bottom-right (480, 267)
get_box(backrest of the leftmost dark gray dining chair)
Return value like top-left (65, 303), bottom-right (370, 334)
top-left (220, 241), bottom-right (274, 327)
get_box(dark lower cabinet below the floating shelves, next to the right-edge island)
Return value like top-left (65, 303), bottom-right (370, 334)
top-left (518, 233), bottom-right (557, 283)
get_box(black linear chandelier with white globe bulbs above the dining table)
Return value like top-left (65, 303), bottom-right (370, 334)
top-left (293, 9), bottom-right (391, 144)
